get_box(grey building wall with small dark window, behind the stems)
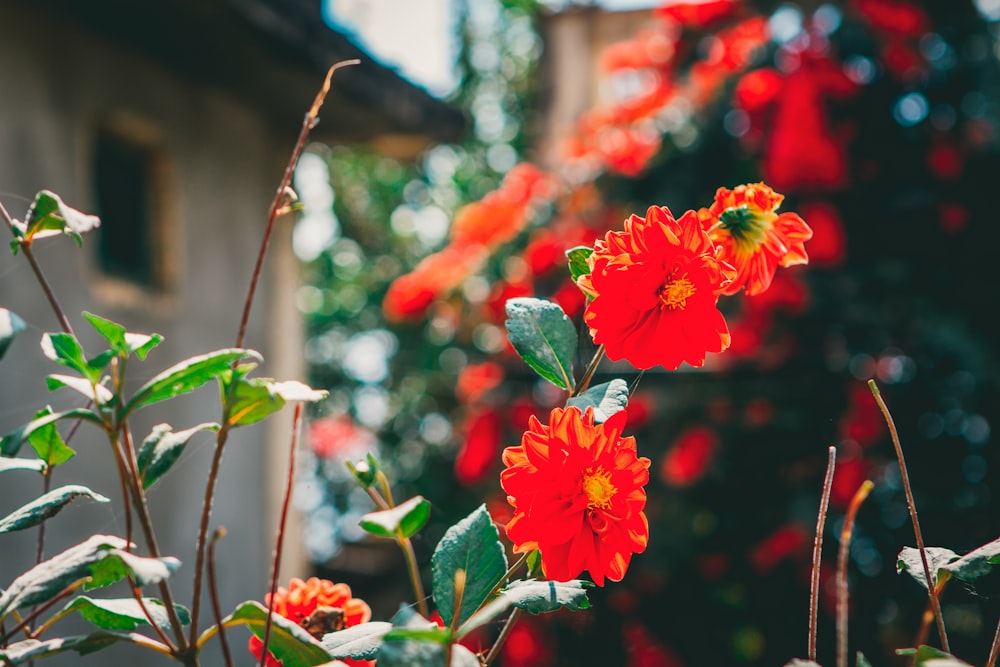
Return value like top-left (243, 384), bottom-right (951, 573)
top-left (0, 6), bottom-right (304, 665)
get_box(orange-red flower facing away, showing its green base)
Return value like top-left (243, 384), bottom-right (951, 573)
top-left (698, 183), bottom-right (812, 296)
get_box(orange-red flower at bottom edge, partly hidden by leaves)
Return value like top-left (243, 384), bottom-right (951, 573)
top-left (248, 577), bottom-right (375, 667)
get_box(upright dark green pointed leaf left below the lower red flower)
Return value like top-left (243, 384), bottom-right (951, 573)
top-left (431, 504), bottom-right (507, 626)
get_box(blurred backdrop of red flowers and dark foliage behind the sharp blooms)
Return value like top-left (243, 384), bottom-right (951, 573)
top-left (294, 0), bottom-right (1000, 667)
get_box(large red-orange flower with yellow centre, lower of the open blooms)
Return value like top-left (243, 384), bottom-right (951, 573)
top-left (500, 407), bottom-right (649, 586)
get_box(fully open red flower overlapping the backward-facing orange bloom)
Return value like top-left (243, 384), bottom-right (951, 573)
top-left (577, 206), bottom-right (736, 370)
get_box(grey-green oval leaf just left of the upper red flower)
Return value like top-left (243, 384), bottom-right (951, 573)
top-left (505, 297), bottom-right (577, 389)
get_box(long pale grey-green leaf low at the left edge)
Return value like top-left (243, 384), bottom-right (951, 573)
top-left (0, 535), bottom-right (128, 618)
